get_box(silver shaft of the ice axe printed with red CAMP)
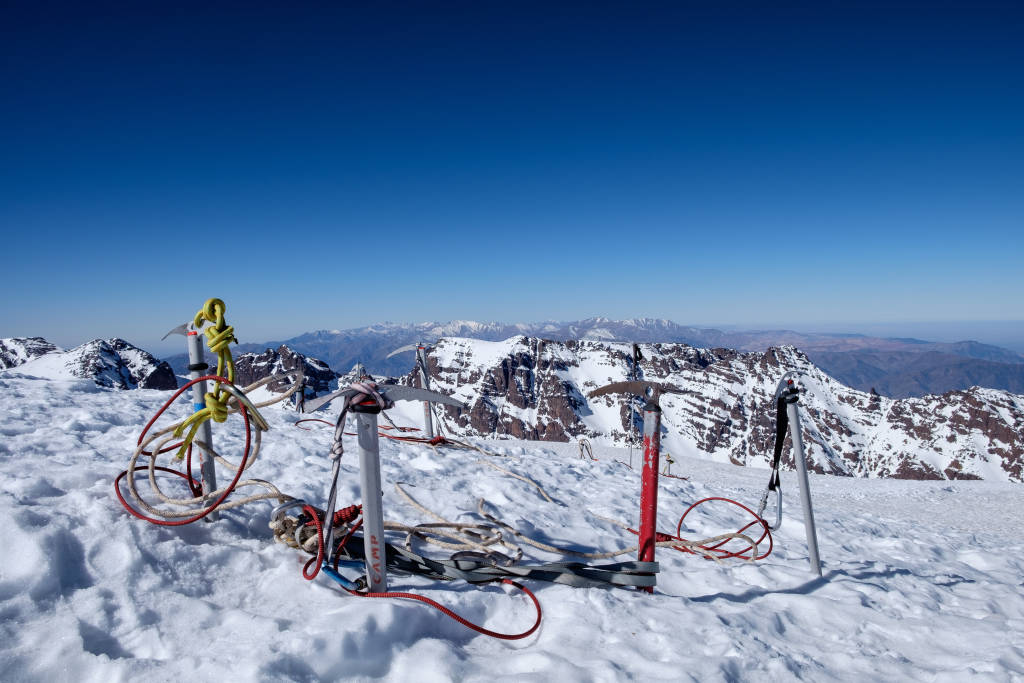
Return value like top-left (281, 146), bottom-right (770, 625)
top-left (352, 405), bottom-right (387, 593)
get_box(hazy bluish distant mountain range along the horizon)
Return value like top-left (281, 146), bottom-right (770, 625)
top-left (167, 317), bottom-right (1024, 398)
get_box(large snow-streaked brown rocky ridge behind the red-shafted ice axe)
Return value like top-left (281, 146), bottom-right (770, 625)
top-left (387, 336), bottom-right (1024, 481)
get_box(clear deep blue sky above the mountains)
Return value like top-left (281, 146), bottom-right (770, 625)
top-left (0, 2), bottom-right (1024, 346)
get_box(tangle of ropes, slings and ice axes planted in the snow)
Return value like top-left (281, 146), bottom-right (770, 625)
top-left (115, 299), bottom-right (816, 640)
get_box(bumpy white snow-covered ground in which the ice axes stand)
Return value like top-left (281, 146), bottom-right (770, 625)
top-left (0, 374), bottom-right (1024, 683)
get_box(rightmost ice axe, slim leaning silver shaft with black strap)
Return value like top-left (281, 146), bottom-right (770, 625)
top-left (770, 372), bottom-right (821, 577)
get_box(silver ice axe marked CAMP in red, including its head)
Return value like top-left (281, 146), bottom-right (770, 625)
top-left (306, 384), bottom-right (468, 593)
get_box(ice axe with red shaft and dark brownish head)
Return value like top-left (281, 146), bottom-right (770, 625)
top-left (587, 382), bottom-right (692, 593)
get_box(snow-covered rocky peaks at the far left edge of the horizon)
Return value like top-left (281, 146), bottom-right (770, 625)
top-left (0, 337), bottom-right (178, 389)
